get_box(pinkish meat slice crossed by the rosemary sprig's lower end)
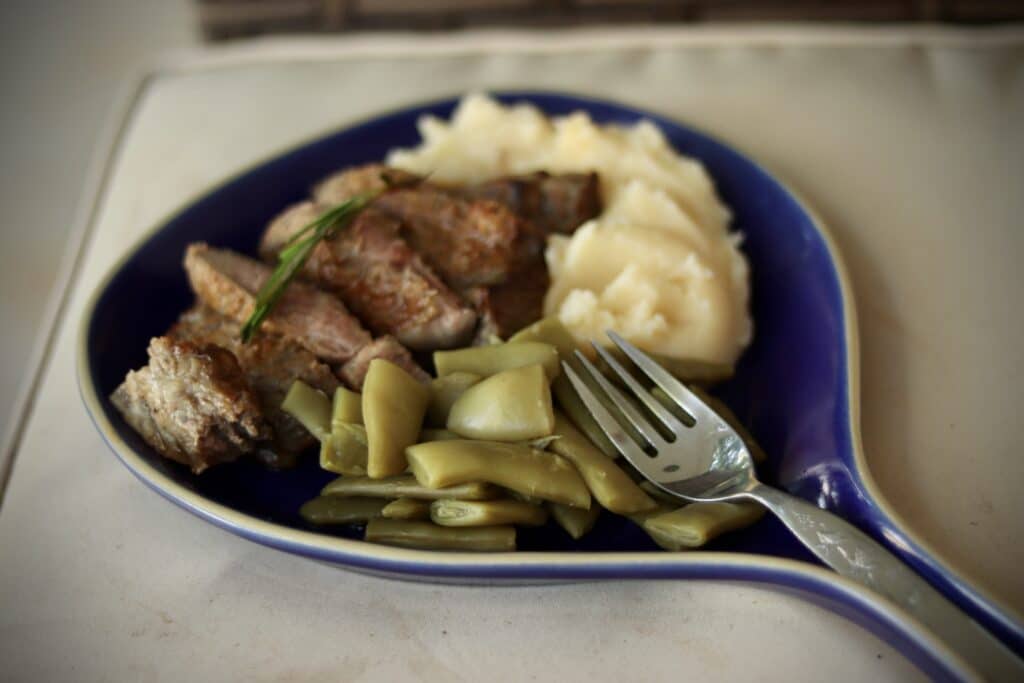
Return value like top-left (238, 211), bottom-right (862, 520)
top-left (184, 243), bottom-right (371, 362)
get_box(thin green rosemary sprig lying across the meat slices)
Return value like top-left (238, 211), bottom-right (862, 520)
top-left (241, 189), bottom-right (383, 342)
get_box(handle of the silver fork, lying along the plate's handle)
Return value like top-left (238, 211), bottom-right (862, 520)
top-left (741, 483), bottom-right (1024, 681)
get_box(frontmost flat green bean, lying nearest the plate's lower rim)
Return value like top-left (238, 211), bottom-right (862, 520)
top-left (366, 519), bottom-right (515, 552)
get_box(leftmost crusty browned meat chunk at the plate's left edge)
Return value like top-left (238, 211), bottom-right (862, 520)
top-left (111, 337), bottom-right (270, 474)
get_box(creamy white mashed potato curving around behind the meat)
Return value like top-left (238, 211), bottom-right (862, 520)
top-left (388, 95), bottom-right (751, 362)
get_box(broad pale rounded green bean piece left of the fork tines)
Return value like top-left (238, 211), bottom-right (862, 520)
top-left (447, 365), bottom-right (555, 441)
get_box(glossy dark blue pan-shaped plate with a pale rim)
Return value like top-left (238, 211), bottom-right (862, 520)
top-left (79, 92), bottom-right (1024, 677)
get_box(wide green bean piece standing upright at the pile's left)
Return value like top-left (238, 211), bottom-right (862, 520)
top-left (362, 358), bottom-right (430, 479)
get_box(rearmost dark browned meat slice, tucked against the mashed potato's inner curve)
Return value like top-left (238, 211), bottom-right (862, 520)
top-left (447, 171), bottom-right (602, 234)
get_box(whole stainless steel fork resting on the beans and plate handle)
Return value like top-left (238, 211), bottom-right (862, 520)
top-left (562, 331), bottom-right (1024, 680)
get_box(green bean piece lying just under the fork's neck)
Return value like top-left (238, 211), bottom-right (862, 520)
top-left (642, 502), bottom-right (765, 551)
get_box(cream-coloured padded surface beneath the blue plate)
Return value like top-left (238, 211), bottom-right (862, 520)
top-left (0, 24), bottom-right (1024, 680)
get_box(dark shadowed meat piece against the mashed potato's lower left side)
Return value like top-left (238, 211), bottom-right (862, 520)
top-left (463, 259), bottom-right (550, 344)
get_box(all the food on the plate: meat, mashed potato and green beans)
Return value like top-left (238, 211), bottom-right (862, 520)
top-left (111, 96), bottom-right (762, 551)
